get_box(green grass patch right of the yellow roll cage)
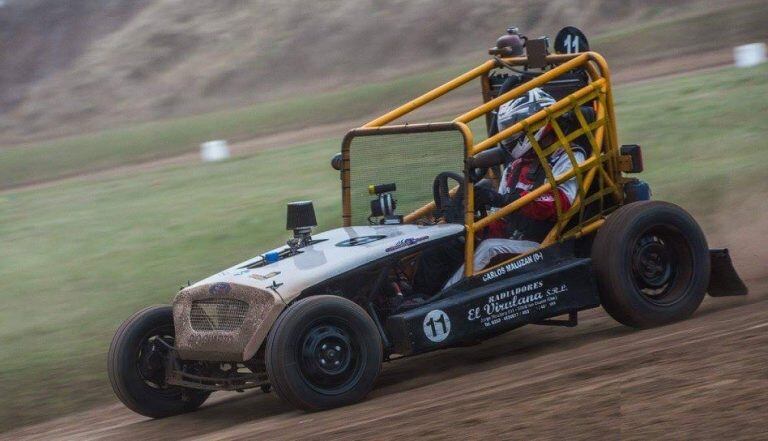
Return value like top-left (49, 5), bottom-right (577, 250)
top-left (616, 66), bottom-right (768, 211)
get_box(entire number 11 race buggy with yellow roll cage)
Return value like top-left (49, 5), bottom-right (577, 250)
top-left (108, 27), bottom-right (747, 418)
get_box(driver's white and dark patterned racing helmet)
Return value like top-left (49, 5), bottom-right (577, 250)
top-left (496, 87), bottom-right (555, 159)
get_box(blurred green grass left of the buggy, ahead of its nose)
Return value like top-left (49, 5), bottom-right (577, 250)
top-left (0, 140), bottom-right (340, 427)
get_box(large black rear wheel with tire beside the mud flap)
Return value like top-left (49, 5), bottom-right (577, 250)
top-left (592, 201), bottom-right (710, 328)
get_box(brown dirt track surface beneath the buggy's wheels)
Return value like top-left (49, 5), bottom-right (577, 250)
top-left (7, 277), bottom-right (768, 440)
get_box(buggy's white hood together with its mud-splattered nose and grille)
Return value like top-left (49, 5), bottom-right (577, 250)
top-left (173, 224), bottom-right (464, 361)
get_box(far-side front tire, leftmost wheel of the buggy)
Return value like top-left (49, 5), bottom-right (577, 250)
top-left (107, 306), bottom-right (210, 418)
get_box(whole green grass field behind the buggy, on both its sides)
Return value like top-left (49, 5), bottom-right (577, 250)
top-left (0, 63), bottom-right (768, 430)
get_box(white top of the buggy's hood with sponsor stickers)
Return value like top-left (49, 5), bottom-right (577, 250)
top-left (192, 224), bottom-right (464, 303)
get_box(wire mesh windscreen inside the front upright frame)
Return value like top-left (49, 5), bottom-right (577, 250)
top-left (345, 125), bottom-right (464, 225)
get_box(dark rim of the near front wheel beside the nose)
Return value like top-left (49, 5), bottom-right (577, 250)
top-left (298, 319), bottom-right (364, 395)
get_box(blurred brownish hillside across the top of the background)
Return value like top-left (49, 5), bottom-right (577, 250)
top-left (0, 0), bottom-right (768, 139)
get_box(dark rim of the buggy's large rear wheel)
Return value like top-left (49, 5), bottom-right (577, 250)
top-left (631, 225), bottom-right (693, 306)
